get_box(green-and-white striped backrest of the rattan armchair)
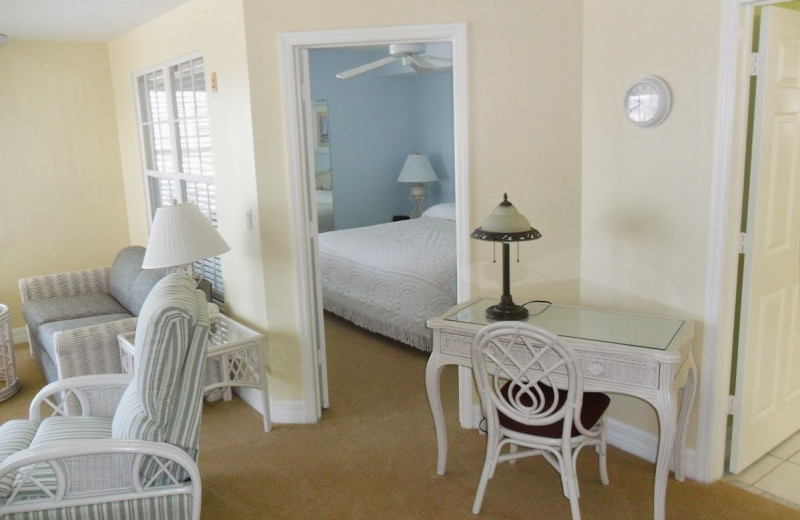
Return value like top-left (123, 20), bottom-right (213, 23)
top-left (111, 274), bottom-right (209, 460)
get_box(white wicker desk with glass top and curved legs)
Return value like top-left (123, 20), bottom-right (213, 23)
top-left (425, 298), bottom-right (696, 520)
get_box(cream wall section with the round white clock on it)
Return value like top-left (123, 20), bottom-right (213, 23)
top-left (581, 0), bottom-right (720, 446)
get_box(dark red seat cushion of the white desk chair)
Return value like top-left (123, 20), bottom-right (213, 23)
top-left (498, 382), bottom-right (611, 439)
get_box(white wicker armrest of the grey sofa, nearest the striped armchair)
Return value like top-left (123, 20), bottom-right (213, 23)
top-left (53, 318), bottom-right (138, 379)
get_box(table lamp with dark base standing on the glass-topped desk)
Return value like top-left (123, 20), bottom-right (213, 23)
top-left (470, 194), bottom-right (542, 321)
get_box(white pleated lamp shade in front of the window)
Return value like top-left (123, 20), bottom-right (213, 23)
top-left (142, 203), bottom-right (231, 269)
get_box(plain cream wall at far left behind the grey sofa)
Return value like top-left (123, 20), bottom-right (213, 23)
top-left (0, 40), bottom-right (130, 328)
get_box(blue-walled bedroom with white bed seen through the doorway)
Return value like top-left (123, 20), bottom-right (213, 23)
top-left (309, 43), bottom-right (456, 351)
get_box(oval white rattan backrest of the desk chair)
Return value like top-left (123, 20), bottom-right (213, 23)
top-left (472, 321), bottom-right (583, 438)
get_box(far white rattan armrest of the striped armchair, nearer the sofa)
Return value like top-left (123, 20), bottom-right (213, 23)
top-left (28, 374), bottom-right (133, 422)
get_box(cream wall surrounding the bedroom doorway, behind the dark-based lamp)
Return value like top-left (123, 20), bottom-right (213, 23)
top-left (244, 0), bottom-right (582, 402)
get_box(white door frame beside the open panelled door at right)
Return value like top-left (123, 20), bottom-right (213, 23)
top-left (696, 0), bottom-right (781, 482)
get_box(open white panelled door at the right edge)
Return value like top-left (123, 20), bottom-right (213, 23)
top-left (729, 7), bottom-right (800, 473)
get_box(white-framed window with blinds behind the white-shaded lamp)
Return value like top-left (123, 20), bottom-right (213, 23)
top-left (135, 56), bottom-right (223, 301)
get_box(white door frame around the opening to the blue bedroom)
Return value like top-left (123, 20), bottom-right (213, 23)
top-left (280, 23), bottom-right (470, 423)
